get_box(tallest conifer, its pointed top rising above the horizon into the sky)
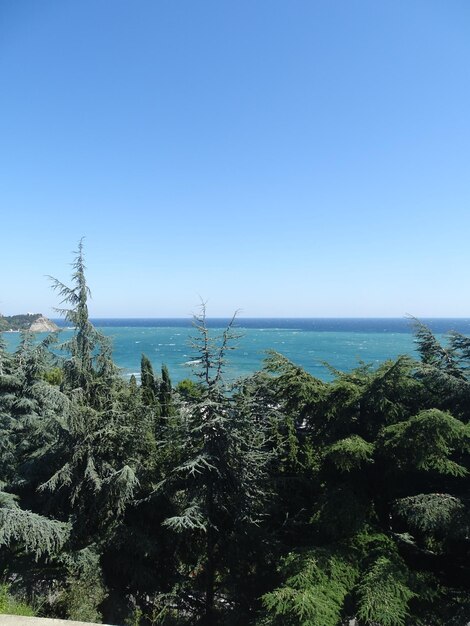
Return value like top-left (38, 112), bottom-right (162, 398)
top-left (41, 240), bottom-right (138, 545)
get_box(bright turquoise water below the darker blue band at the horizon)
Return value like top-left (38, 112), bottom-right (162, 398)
top-left (103, 327), bottom-right (413, 380)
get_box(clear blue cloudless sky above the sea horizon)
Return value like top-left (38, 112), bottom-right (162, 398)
top-left (0, 0), bottom-right (470, 317)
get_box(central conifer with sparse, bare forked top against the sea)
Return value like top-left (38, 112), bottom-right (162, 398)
top-left (161, 308), bottom-right (269, 626)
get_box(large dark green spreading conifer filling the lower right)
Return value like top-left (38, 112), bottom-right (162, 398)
top-left (261, 342), bottom-right (470, 626)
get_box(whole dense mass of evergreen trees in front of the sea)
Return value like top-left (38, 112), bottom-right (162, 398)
top-left (0, 242), bottom-right (470, 626)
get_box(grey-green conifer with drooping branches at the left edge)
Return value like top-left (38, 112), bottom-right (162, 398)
top-left (0, 332), bottom-right (70, 604)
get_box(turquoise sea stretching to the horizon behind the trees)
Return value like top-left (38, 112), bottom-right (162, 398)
top-left (3, 318), bottom-right (470, 382)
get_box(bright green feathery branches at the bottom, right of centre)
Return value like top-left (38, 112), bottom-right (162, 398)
top-left (261, 531), bottom-right (416, 626)
